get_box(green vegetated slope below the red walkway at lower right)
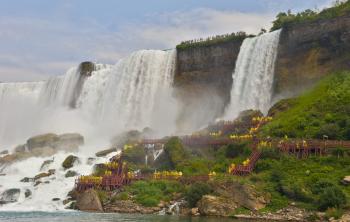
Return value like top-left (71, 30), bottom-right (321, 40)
top-left (248, 155), bottom-right (350, 211)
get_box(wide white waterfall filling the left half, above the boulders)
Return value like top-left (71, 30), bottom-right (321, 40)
top-left (0, 50), bottom-right (176, 150)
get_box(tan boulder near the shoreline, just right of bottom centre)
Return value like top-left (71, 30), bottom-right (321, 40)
top-left (197, 195), bottom-right (238, 216)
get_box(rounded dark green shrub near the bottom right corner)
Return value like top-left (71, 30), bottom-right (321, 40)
top-left (318, 186), bottom-right (346, 210)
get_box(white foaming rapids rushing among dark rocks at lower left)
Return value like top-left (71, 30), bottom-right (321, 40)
top-left (0, 152), bottom-right (117, 211)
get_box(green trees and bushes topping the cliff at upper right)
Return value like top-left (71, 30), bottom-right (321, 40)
top-left (271, 1), bottom-right (350, 31)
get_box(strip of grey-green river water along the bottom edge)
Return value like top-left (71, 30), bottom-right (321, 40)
top-left (0, 212), bottom-right (249, 222)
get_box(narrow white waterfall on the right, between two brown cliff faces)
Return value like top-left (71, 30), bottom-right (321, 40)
top-left (225, 30), bottom-right (281, 118)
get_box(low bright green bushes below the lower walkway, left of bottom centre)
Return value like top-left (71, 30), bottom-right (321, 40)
top-left (123, 181), bottom-right (183, 207)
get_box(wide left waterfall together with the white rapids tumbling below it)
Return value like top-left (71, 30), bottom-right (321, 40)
top-left (0, 50), bottom-right (176, 211)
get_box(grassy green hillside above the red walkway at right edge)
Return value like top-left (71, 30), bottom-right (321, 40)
top-left (262, 72), bottom-right (350, 140)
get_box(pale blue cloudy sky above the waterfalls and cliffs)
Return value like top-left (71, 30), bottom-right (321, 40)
top-left (0, 0), bottom-right (333, 82)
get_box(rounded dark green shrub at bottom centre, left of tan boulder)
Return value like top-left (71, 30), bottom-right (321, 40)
top-left (185, 183), bottom-right (213, 207)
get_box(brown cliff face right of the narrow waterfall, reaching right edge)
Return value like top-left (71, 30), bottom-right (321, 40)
top-left (274, 15), bottom-right (350, 100)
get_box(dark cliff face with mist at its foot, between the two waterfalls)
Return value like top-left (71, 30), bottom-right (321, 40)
top-left (175, 40), bottom-right (242, 129)
